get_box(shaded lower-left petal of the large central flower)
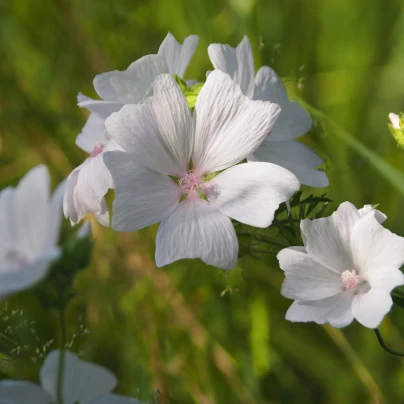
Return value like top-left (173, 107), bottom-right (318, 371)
top-left (104, 152), bottom-right (181, 231)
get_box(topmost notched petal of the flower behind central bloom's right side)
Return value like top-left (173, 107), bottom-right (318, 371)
top-left (208, 36), bottom-right (254, 98)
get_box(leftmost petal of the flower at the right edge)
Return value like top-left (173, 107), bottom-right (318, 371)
top-left (277, 248), bottom-right (343, 300)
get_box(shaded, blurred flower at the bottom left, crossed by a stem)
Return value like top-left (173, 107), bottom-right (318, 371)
top-left (0, 351), bottom-right (141, 404)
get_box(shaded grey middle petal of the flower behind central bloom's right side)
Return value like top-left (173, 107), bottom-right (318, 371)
top-left (254, 66), bottom-right (313, 141)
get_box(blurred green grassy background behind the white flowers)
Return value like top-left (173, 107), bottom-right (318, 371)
top-left (0, 0), bottom-right (404, 404)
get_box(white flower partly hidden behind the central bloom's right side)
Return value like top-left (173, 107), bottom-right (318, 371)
top-left (208, 36), bottom-right (328, 188)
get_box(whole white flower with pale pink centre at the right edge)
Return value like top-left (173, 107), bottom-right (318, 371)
top-left (278, 202), bottom-right (404, 328)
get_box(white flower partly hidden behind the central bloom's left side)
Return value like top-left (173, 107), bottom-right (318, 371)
top-left (63, 33), bottom-right (199, 226)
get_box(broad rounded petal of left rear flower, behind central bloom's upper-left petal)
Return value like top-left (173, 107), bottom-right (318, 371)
top-left (93, 55), bottom-right (168, 104)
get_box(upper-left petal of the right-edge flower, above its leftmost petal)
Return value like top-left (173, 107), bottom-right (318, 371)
top-left (300, 202), bottom-right (360, 274)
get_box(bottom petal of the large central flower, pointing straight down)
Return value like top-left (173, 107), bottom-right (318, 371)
top-left (156, 196), bottom-right (238, 269)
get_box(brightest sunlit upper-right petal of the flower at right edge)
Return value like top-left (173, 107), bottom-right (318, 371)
top-left (351, 215), bottom-right (404, 279)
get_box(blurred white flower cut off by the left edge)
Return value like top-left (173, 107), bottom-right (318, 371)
top-left (0, 165), bottom-right (64, 297)
